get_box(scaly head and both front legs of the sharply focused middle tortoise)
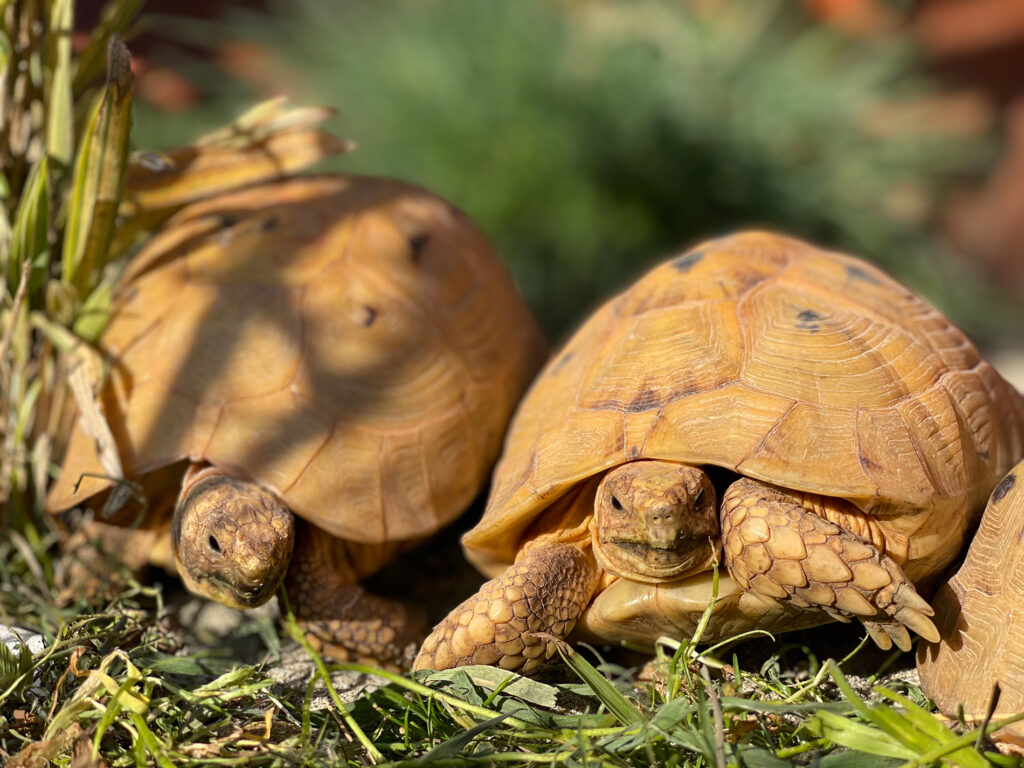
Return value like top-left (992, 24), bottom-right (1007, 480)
top-left (414, 461), bottom-right (937, 672)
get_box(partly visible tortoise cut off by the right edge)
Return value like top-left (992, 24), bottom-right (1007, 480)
top-left (918, 461), bottom-right (1024, 746)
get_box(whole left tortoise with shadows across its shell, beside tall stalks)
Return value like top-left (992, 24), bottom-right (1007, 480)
top-left (46, 175), bottom-right (546, 660)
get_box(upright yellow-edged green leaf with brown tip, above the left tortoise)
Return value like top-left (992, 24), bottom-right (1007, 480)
top-left (61, 38), bottom-right (132, 295)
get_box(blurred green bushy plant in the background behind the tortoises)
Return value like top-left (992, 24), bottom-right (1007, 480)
top-left (117, 0), bottom-right (1024, 342)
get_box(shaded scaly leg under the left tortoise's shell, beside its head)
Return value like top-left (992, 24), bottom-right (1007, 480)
top-left (284, 520), bottom-right (427, 667)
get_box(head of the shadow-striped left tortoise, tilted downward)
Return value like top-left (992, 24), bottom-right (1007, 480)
top-left (172, 467), bottom-right (295, 608)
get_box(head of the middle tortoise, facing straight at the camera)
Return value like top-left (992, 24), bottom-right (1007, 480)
top-left (591, 461), bottom-right (721, 582)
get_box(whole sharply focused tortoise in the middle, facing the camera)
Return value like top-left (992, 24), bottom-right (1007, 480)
top-left (415, 232), bottom-right (1024, 672)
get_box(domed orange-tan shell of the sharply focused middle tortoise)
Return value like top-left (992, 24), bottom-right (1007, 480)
top-left (463, 232), bottom-right (1024, 580)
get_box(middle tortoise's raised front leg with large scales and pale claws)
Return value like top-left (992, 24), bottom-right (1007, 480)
top-left (722, 477), bottom-right (938, 650)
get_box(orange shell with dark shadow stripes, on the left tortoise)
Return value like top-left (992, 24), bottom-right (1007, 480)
top-left (47, 175), bottom-right (545, 544)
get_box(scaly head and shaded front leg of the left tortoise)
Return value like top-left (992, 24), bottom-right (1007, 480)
top-left (178, 467), bottom-right (426, 667)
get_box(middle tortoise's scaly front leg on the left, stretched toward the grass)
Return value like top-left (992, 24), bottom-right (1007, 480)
top-left (413, 544), bottom-right (598, 672)
